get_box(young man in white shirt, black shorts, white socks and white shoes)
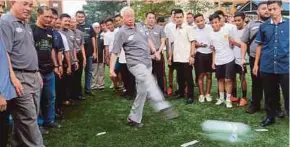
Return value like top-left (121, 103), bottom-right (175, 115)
top-left (209, 14), bottom-right (235, 108)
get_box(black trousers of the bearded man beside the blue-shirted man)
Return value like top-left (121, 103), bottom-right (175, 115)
top-left (250, 57), bottom-right (263, 108)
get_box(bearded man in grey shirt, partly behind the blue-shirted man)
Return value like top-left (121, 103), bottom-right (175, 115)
top-left (241, 1), bottom-right (283, 115)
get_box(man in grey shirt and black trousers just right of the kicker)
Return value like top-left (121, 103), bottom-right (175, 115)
top-left (146, 12), bottom-right (166, 94)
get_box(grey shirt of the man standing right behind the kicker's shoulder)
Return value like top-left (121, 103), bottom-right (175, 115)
top-left (147, 25), bottom-right (166, 51)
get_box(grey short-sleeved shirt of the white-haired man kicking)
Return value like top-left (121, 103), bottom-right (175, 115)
top-left (112, 23), bottom-right (152, 68)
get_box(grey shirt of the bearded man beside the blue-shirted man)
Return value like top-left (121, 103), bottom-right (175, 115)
top-left (241, 20), bottom-right (263, 58)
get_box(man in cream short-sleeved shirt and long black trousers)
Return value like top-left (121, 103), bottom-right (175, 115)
top-left (169, 9), bottom-right (195, 104)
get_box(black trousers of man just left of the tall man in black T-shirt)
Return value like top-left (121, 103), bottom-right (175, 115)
top-left (72, 51), bottom-right (84, 99)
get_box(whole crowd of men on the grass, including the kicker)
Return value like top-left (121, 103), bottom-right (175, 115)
top-left (0, 0), bottom-right (289, 147)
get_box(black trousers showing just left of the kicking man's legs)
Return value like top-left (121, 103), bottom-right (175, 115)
top-left (120, 63), bottom-right (136, 96)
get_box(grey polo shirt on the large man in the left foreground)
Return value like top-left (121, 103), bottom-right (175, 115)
top-left (0, 12), bottom-right (38, 70)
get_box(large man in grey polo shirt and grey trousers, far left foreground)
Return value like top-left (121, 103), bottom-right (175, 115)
top-left (0, 0), bottom-right (43, 147)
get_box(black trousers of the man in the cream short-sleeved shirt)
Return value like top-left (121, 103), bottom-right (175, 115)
top-left (175, 62), bottom-right (193, 98)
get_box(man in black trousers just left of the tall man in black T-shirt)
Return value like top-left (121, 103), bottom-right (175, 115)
top-left (70, 18), bottom-right (87, 100)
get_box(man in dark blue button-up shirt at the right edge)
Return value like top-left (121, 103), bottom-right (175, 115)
top-left (253, 0), bottom-right (289, 127)
